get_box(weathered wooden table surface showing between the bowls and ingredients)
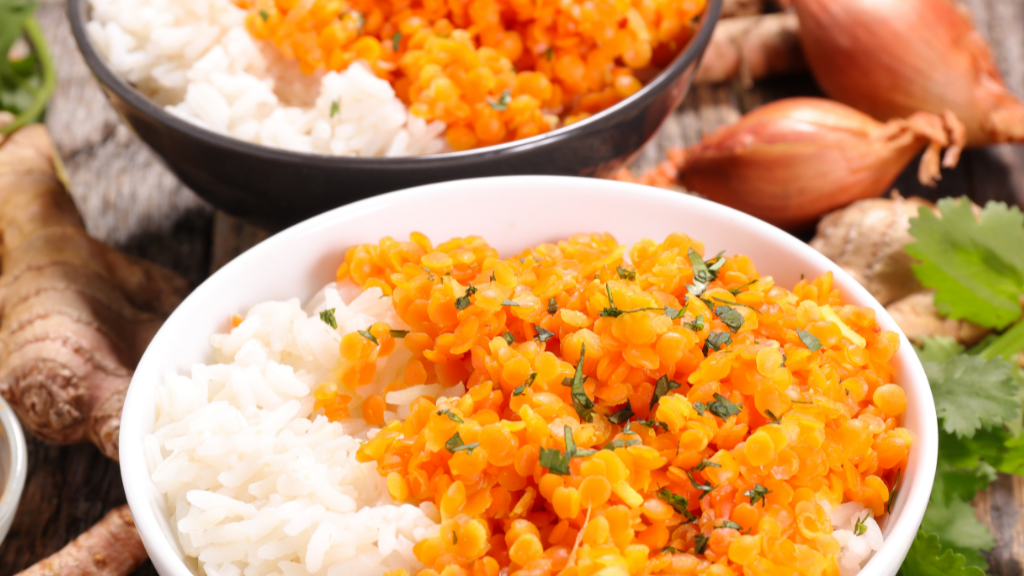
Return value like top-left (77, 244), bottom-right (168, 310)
top-left (0, 0), bottom-right (1024, 576)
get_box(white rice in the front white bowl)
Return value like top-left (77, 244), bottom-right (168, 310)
top-left (145, 284), bottom-right (465, 576)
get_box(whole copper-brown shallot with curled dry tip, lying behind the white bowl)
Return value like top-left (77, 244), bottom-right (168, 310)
top-left (675, 98), bottom-right (963, 230)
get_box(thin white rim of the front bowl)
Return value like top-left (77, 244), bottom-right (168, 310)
top-left (120, 175), bottom-right (938, 576)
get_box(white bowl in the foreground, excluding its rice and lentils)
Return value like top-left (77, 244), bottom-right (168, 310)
top-left (120, 176), bottom-right (938, 576)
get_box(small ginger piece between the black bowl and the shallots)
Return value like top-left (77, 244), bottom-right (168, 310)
top-left (693, 12), bottom-right (807, 87)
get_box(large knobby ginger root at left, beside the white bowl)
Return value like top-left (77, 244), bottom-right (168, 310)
top-left (0, 125), bottom-right (188, 460)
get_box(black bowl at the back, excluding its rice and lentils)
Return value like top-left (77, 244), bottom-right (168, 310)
top-left (68, 0), bottom-right (722, 229)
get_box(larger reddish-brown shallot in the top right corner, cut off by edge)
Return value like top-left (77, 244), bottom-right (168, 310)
top-left (794, 0), bottom-right (1024, 146)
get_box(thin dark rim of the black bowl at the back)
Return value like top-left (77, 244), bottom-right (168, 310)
top-left (68, 0), bottom-right (724, 168)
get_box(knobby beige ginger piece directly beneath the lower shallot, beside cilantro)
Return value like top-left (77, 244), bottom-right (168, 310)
top-left (811, 193), bottom-right (935, 305)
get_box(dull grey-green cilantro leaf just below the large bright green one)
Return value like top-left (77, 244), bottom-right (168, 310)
top-left (922, 336), bottom-right (1021, 438)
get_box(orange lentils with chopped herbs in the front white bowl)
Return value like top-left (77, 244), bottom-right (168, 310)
top-left (316, 234), bottom-right (911, 576)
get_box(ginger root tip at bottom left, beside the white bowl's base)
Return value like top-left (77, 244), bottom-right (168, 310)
top-left (17, 504), bottom-right (148, 576)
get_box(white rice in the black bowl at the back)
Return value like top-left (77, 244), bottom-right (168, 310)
top-left (86, 0), bottom-right (447, 157)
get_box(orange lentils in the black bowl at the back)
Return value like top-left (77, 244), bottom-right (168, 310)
top-left (237, 0), bottom-right (706, 150)
